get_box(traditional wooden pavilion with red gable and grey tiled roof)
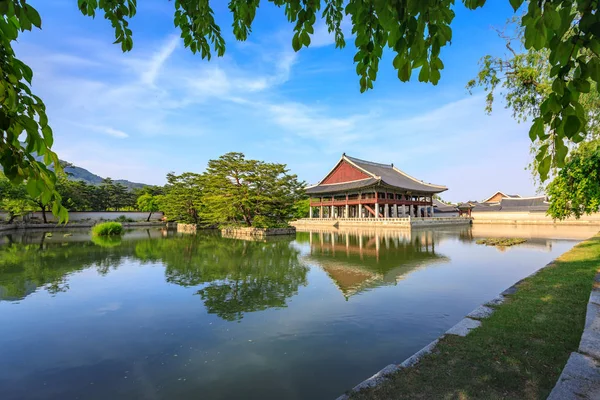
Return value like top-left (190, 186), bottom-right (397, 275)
top-left (306, 153), bottom-right (448, 219)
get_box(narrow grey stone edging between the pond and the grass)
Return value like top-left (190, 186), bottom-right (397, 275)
top-left (336, 261), bottom-right (552, 400)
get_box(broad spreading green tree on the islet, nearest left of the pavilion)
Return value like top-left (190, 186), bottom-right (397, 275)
top-left (202, 153), bottom-right (304, 227)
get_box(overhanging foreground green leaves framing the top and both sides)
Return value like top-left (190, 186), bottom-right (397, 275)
top-left (0, 0), bottom-right (600, 219)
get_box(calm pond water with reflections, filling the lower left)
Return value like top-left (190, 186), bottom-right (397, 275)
top-left (0, 226), bottom-right (595, 400)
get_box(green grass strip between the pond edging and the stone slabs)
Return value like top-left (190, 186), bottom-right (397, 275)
top-left (351, 234), bottom-right (600, 400)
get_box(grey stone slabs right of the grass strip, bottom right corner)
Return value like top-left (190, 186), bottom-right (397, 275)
top-left (548, 273), bottom-right (600, 400)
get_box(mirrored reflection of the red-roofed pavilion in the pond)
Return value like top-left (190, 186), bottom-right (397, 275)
top-left (297, 228), bottom-right (449, 299)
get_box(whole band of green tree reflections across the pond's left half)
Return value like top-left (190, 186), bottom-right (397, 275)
top-left (0, 230), bottom-right (308, 321)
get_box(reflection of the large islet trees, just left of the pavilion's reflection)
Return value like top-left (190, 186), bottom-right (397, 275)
top-left (136, 234), bottom-right (308, 321)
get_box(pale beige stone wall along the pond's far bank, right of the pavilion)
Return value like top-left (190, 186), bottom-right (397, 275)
top-left (471, 211), bottom-right (600, 225)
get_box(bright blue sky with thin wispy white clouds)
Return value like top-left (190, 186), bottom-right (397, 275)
top-left (16, 0), bottom-right (535, 201)
